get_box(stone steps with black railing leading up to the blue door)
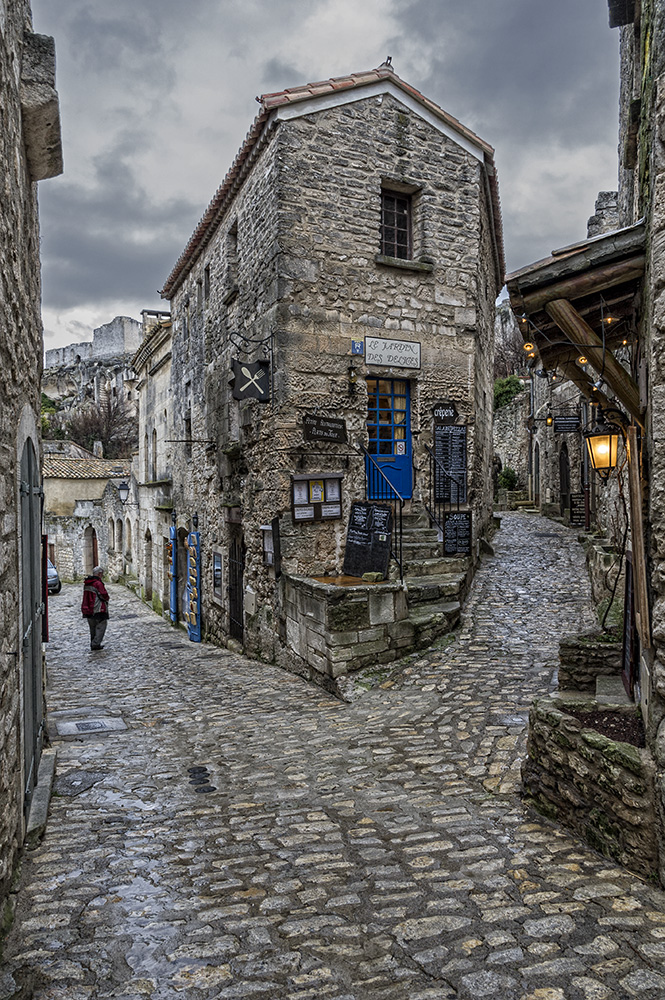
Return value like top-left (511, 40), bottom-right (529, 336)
top-left (393, 512), bottom-right (471, 648)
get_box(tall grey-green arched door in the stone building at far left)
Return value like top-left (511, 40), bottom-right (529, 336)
top-left (20, 441), bottom-right (44, 814)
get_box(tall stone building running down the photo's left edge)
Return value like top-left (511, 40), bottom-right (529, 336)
top-left (0, 0), bottom-right (62, 913)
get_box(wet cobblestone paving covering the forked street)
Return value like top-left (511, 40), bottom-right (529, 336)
top-left (0, 513), bottom-right (665, 1000)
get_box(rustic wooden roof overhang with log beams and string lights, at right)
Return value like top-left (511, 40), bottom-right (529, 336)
top-left (506, 221), bottom-right (645, 426)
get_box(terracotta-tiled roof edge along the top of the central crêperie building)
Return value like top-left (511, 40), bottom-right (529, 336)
top-left (161, 66), bottom-right (505, 298)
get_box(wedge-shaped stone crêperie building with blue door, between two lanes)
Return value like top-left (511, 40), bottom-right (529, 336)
top-left (158, 63), bottom-right (504, 683)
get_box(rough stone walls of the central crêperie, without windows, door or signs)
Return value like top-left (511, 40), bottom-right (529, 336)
top-left (163, 80), bottom-right (497, 672)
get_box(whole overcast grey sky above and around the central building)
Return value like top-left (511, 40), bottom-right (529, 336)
top-left (32, 0), bottom-right (618, 348)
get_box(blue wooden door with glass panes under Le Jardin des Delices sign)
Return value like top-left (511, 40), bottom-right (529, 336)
top-left (367, 378), bottom-right (413, 500)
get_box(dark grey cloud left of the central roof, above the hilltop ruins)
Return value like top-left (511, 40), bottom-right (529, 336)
top-left (40, 155), bottom-right (200, 309)
